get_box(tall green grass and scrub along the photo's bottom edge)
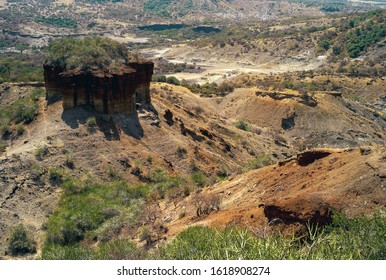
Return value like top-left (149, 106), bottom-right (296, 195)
top-left (42, 214), bottom-right (386, 260)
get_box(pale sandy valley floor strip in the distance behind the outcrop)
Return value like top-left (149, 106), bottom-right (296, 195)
top-left (141, 42), bottom-right (327, 84)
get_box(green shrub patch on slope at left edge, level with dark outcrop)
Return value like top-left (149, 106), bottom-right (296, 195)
top-left (0, 89), bottom-right (44, 138)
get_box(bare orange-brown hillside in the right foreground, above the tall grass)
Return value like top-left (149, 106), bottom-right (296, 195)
top-left (163, 147), bottom-right (386, 236)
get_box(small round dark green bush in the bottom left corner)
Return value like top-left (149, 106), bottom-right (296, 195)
top-left (8, 225), bottom-right (36, 256)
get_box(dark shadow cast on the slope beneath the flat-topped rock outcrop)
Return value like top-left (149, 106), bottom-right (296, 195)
top-left (62, 107), bottom-right (144, 141)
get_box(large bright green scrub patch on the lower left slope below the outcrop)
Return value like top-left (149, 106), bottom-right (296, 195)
top-left (45, 178), bottom-right (147, 246)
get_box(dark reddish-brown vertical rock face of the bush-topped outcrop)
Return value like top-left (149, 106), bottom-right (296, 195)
top-left (44, 62), bottom-right (154, 114)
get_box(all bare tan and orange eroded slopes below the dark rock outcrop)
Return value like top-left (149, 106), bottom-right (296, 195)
top-left (0, 76), bottom-right (386, 254)
